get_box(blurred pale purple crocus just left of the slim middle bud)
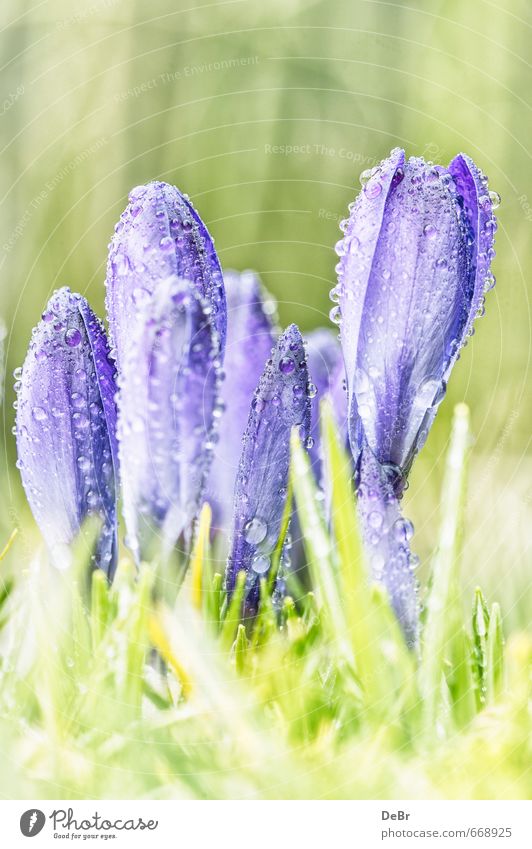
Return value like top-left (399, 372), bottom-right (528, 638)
top-left (205, 271), bottom-right (276, 533)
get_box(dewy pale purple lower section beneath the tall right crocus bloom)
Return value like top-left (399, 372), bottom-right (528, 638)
top-left (357, 446), bottom-right (419, 647)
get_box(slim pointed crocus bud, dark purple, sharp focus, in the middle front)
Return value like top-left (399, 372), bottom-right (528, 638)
top-left (226, 324), bottom-right (311, 614)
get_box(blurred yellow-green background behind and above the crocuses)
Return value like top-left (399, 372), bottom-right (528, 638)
top-left (0, 0), bottom-right (532, 626)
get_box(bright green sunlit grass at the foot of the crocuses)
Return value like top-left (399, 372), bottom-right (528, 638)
top-left (0, 405), bottom-right (532, 799)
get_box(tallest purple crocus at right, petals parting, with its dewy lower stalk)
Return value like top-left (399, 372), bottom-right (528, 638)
top-left (332, 149), bottom-right (496, 642)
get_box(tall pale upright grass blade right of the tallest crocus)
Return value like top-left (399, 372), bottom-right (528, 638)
top-left (419, 404), bottom-right (475, 740)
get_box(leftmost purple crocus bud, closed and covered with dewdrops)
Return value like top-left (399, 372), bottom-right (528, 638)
top-left (15, 288), bottom-right (117, 577)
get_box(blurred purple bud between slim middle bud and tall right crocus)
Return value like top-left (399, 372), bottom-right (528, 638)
top-left (305, 327), bottom-right (347, 474)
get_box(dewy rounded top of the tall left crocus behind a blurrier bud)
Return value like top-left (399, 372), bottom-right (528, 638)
top-left (106, 182), bottom-right (226, 366)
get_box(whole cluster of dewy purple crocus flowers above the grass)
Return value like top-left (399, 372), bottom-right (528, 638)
top-left (16, 150), bottom-right (496, 644)
